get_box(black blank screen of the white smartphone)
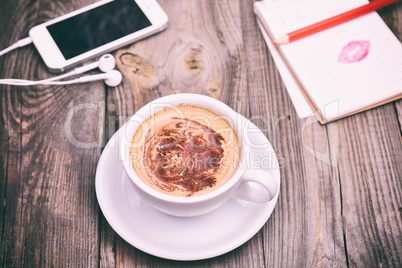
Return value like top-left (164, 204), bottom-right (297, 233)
top-left (47, 0), bottom-right (151, 60)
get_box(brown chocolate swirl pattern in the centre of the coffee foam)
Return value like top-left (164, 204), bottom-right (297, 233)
top-left (144, 117), bottom-right (225, 195)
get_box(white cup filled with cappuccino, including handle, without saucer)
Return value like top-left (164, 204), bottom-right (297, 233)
top-left (119, 93), bottom-right (279, 217)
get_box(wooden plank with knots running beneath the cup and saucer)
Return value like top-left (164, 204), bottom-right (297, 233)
top-left (101, 0), bottom-right (264, 267)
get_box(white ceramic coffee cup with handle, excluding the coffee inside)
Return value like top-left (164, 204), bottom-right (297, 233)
top-left (120, 93), bottom-right (279, 217)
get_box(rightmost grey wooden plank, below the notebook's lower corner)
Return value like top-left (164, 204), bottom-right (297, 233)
top-left (339, 104), bottom-right (402, 267)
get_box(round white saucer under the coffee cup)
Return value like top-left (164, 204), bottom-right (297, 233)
top-left (96, 118), bottom-right (280, 260)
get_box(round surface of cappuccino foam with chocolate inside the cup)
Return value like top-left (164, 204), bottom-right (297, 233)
top-left (130, 105), bottom-right (241, 196)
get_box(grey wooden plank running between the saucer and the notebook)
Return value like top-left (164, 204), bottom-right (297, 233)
top-left (242, 1), bottom-right (346, 267)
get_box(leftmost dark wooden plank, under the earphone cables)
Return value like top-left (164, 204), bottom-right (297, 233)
top-left (0, 1), bottom-right (105, 267)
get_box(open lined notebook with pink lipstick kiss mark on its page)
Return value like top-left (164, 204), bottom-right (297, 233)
top-left (254, 0), bottom-right (402, 124)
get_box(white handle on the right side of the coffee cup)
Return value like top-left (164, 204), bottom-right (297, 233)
top-left (234, 169), bottom-right (279, 203)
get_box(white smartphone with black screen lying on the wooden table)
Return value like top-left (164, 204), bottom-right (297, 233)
top-left (29, 0), bottom-right (168, 72)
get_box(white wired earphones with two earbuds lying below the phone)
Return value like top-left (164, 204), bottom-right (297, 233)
top-left (0, 54), bottom-right (123, 87)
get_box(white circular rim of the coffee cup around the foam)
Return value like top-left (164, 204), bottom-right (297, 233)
top-left (119, 93), bottom-right (250, 204)
